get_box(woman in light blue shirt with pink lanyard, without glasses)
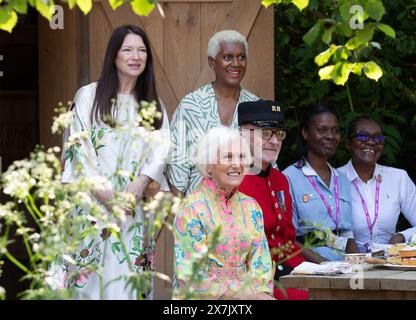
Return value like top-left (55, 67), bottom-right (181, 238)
top-left (283, 105), bottom-right (358, 262)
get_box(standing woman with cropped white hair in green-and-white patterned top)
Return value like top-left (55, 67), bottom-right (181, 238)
top-left (167, 30), bottom-right (259, 194)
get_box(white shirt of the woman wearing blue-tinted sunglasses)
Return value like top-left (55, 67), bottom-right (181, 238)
top-left (338, 160), bottom-right (416, 246)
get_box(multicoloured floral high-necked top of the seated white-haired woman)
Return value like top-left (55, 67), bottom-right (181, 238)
top-left (173, 178), bottom-right (274, 299)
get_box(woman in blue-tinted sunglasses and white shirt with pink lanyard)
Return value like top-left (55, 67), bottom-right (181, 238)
top-left (338, 116), bottom-right (416, 252)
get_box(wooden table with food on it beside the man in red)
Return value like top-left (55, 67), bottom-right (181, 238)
top-left (280, 266), bottom-right (416, 300)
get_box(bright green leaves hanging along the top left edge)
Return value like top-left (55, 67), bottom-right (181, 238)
top-left (0, 0), bottom-right (157, 32)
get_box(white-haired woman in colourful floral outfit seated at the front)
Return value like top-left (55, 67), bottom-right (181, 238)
top-left (173, 126), bottom-right (274, 299)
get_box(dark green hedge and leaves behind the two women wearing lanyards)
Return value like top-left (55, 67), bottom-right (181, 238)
top-left (275, 0), bottom-right (416, 179)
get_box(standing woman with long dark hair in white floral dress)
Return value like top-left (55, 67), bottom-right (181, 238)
top-left (62, 25), bottom-right (169, 299)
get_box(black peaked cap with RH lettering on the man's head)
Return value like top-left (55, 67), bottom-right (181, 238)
top-left (238, 100), bottom-right (285, 129)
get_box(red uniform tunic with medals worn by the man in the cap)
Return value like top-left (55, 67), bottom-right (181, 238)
top-left (238, 166), bottom-right (308, 300)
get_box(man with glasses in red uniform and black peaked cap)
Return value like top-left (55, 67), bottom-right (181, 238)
top-left (238, 100), bottom-right (308, 300)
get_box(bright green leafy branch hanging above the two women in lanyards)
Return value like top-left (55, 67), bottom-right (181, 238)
top-left (303, 0), bottom-right (395, 86)
